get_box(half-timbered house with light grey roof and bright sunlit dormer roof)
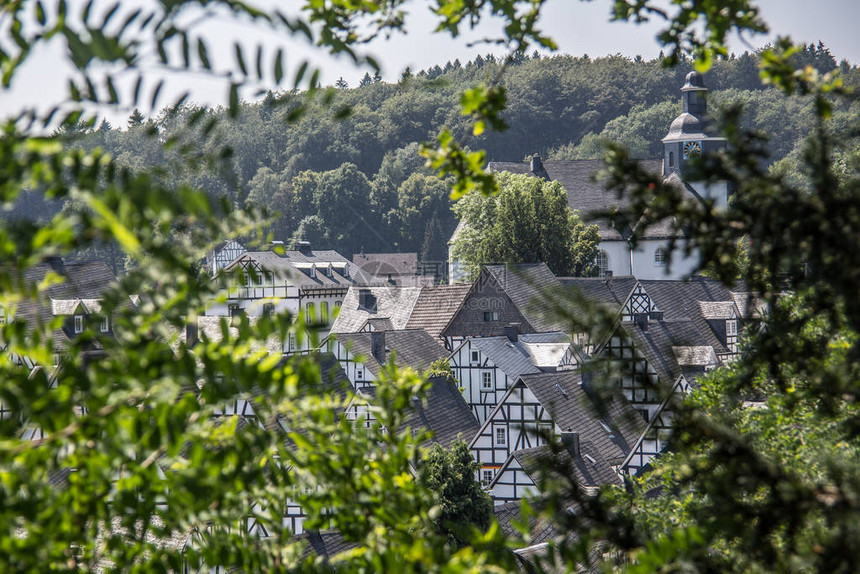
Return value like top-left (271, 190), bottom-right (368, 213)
top-left (448, 325), bottom-right (582, 423)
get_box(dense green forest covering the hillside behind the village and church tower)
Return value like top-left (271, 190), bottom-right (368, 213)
top-left (11, 43), bottom-right (860, 268)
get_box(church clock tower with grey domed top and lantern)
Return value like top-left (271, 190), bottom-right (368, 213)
top-left (663, 72), bottom-right (726, 180)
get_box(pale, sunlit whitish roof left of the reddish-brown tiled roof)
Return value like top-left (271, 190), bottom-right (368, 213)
top-left (330, 286), bottom-right (421, 333)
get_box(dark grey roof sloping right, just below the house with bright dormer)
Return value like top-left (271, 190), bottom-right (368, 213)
top-left (520, 371), bottom-right (645, 464)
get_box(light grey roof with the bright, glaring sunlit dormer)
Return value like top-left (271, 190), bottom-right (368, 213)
top-left (469, 332), bottom-right (570, 380)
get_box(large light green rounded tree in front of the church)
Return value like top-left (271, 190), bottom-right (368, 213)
top-left (453, 172), bottom-right (599, 276)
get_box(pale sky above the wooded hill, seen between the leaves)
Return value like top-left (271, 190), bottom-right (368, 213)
top-left (0, 0), bottom-right (860, 125)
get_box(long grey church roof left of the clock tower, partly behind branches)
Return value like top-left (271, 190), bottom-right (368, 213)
top-left (487, 159), bottom-right (691, 241)
